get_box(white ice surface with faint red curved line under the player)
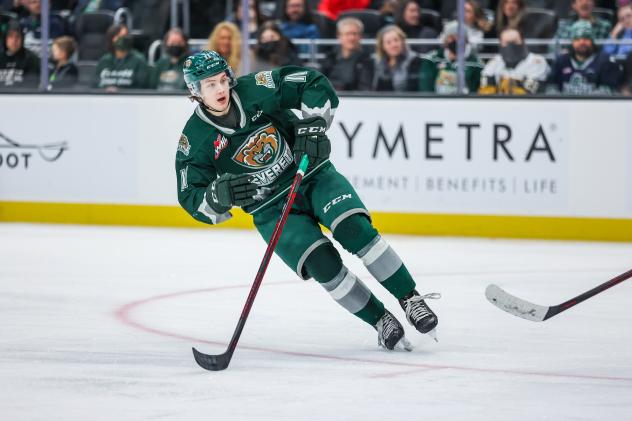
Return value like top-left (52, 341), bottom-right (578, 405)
top-left (0, 224), bottom-right (632, 421)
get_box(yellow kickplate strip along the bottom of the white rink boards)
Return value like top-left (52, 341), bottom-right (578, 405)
top-left (0, 202), bottom-right (632, 241)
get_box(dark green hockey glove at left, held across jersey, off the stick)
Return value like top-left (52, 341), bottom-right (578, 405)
top-left (206, 173), bottom-right (272, 213)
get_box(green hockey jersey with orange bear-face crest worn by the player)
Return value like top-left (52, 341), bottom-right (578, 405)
top-left (176, 66), bottom-right (338, 224)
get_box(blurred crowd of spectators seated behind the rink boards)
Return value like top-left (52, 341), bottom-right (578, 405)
top-left (0, 0), bottom-right (632, 95)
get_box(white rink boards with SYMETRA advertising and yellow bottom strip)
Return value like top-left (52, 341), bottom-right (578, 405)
top-left (0, 95), bottom-right (632, 241)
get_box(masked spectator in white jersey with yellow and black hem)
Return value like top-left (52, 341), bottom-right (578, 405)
top-left (478, 28), bottom-right (549, 95)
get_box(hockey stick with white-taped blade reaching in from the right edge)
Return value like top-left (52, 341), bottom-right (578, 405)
top-left (485, 269), bottom-right (632, 322)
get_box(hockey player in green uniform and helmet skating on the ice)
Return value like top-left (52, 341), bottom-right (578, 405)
top-left (176, 51), bottom-right (438, 350)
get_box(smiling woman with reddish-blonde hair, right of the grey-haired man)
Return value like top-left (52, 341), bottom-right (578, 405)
top-left (372, 25), bottom-right (421, 92)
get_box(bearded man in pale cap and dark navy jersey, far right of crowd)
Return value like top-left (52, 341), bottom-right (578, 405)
top-left (547, 20), bottom-right (621, 95)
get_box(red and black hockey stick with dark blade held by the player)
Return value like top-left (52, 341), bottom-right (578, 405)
top-left (193, 155), bottom-right (309, 371)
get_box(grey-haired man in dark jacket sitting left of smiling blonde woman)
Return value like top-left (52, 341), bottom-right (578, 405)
top-left (322, 18), bottom-right (373, 91)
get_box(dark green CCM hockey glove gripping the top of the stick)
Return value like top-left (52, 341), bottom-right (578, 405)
top-left (294, 117), bottom-right (331, 165)
